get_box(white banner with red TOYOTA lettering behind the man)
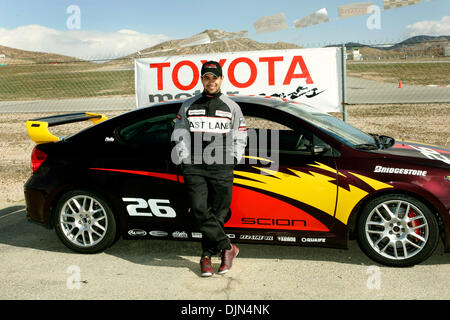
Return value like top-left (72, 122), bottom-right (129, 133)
top-left (135, 48), bottom-right (342, 112)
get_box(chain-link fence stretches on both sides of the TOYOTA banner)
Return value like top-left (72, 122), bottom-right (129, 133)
top-left (0, 44), bottom-right (450, 112)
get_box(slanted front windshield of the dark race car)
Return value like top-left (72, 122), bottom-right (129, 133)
top-left (280, 103), bottom-right (377, 147)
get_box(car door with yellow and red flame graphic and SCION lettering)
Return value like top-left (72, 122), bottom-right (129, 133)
top-left (225, 106), bottom-right (337, 245)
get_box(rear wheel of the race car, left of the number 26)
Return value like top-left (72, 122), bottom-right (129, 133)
top-left (53, 190), bottom-right (116, 253)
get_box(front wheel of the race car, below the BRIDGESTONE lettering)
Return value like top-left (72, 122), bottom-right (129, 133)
top-left (357, 194), bottom-right (439, 267)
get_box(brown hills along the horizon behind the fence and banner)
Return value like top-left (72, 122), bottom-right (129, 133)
top-left (0, 29), bottom-right (450, 68)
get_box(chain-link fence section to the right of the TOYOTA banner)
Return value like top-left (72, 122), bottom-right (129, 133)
top-left (346, 55), bottom-right (450, 104)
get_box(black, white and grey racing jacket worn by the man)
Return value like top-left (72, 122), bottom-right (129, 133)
top-left (173, 91), bottom-right (247, 164)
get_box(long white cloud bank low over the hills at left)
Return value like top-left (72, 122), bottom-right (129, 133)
top-left (0, 25), bottom-right (169, 59)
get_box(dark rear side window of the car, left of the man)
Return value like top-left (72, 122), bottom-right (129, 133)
top-left (118, 114), bottom-right (176, 147)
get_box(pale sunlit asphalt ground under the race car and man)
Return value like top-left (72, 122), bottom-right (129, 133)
top-left (0, 203), bottom-right (450, 300)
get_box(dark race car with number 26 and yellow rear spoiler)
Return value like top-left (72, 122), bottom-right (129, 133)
top-left (24, 96), bottom-right (450, 267)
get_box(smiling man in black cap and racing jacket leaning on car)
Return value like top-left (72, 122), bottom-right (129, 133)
top-left (175, 61), bottom-right (247, 277)
